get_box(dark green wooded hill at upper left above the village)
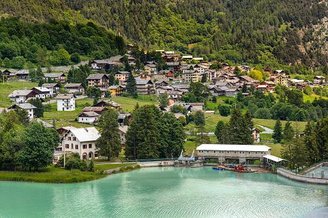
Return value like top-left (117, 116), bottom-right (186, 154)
top-left (0, 18), bottom-right (125, 68)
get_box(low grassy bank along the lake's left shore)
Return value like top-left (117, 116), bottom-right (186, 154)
top-left (0, 167), bottom-right (106, 183)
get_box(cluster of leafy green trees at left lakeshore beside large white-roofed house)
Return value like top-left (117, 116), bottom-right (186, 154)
top-left (0, 110), bottom-right (59, 171)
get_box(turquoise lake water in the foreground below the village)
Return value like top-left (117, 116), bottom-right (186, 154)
top-left (0, 168), bottom-right (328, 218)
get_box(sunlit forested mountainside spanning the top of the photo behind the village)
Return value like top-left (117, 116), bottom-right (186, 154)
top-left (0, 0), bottom-right (328, 70)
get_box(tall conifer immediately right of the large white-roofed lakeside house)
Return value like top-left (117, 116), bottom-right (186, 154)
top-left (96, 109), bottom-right (121, 160)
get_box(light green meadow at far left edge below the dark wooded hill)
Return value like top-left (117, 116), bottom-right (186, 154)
top-left (0, 81), bottom-right (37, 107)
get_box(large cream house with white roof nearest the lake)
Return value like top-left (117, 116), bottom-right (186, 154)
top-left (58, 127), bottom-right (100, 160)
